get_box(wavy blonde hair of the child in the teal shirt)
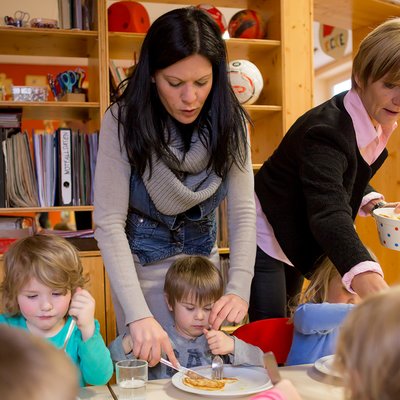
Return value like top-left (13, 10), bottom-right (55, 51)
top-left (0, 235), bottom-right (87, 316)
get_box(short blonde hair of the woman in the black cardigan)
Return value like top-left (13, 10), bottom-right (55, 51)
top-left (351, 18), bottom-right (400, 89)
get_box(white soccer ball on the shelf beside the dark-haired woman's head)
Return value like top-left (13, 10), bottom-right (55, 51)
top-left (228, 60), bottom-right (264, 104)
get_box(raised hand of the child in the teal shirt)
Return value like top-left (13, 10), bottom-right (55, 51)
top-left (69, 288), bottom-right (95, 340)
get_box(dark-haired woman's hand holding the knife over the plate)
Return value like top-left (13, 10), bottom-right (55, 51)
top-left (129, 317), bottom-right (179, 367)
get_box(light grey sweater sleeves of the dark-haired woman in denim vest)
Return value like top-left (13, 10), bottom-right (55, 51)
top-left (94, 106), bottom-right (256, 324)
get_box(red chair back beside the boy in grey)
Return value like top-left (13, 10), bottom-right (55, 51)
top-left (232, 318), bottom-right (293, 365)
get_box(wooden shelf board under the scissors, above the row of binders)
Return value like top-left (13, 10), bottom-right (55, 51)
top-left (0, 101), bottom-right (100, 121)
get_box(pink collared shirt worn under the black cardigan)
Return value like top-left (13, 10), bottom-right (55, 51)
top-left (255, 89), bottom-right (397, 293)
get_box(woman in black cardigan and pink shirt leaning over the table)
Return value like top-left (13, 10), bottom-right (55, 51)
top-left (249, 18), bottom-right (400, 321)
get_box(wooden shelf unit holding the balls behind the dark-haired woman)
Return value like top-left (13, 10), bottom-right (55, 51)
top-left (107, 0), bottom-right (313, 163)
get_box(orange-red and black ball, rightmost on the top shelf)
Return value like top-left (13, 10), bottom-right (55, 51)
top-left (228, 10), bottom-right (267, 39)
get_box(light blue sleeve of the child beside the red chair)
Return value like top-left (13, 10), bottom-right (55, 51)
top-left (293, 303), bottom-right (354, 335)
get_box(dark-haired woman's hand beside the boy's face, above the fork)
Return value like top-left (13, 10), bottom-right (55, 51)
top-left (208, 294), bottom-right (249, 330)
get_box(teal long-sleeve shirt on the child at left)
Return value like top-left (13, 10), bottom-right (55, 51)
top-left (0, 314), bottom-right (113, 386)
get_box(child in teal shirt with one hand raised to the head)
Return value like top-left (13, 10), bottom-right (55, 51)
top-left (0, 235), bottom-right (113, 386)
